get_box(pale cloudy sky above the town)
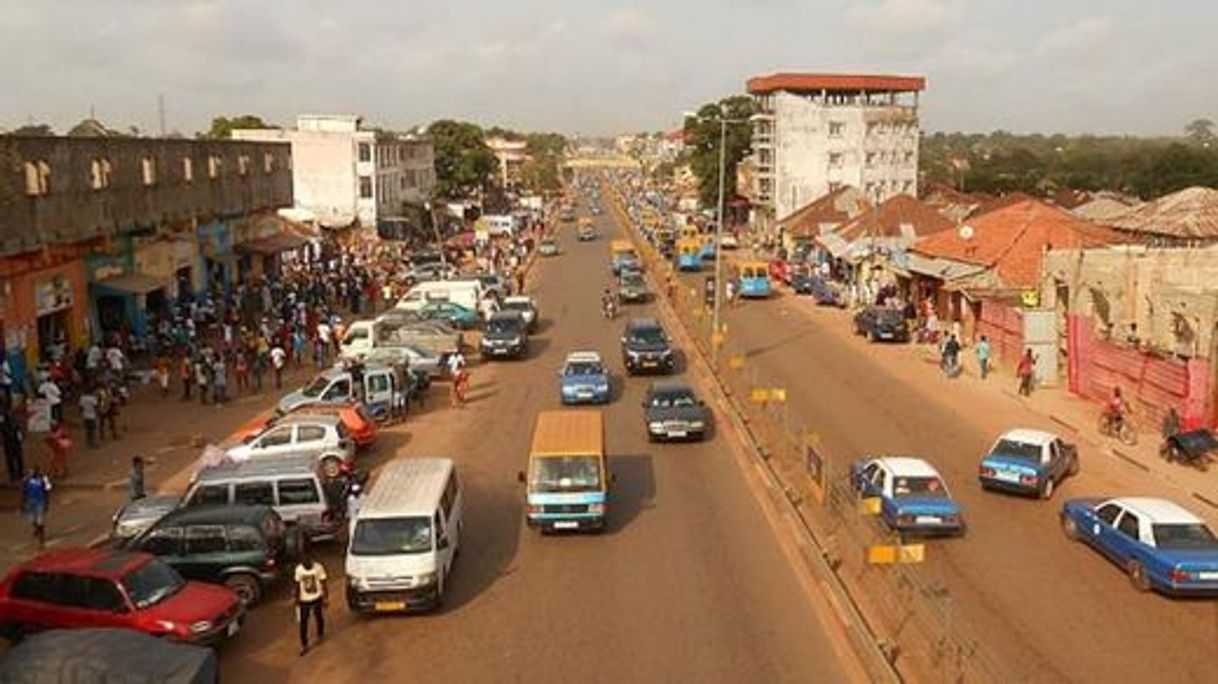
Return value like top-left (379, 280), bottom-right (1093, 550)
top-left (0, 0), bottom-right (1218, 135)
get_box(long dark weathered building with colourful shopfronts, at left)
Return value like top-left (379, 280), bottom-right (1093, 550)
top-left (0, 136), bottom-right (292, 372)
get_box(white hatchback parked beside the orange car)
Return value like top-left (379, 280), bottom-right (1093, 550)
top-left (225, 413), bottom-right (356, 478)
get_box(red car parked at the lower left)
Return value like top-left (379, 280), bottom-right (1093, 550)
top-left (0, 548), bottom-right (245, 644)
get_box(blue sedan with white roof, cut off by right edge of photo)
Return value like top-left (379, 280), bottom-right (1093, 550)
top-left (1061, 497), bottom-right (1218, 594)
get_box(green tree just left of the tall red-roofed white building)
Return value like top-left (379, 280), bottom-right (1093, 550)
top-left (685, 95), bottom-right (756, 207)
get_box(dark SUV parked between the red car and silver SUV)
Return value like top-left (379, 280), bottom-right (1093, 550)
top-left (124, 505), bottom-right (294, 605)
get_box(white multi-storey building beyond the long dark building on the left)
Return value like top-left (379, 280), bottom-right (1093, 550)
top-left (233, 114), bottom-right (435, 229)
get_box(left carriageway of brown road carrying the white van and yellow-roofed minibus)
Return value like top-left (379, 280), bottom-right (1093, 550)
top-left (222, 199), bottom-right (854, 684)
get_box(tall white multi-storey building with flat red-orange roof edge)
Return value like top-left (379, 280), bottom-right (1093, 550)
top-left (748, 73), bottom-right (926, 228)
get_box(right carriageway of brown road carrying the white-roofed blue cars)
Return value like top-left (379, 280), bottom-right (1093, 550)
top-left (706, 273), bottom-right (1218, 682)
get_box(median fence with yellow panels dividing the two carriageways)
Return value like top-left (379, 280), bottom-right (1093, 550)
top-left (613, 183), bottom-right (1017, 682)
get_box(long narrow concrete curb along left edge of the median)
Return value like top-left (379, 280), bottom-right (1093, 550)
top-left (613, 186), bottom-right (904, 682)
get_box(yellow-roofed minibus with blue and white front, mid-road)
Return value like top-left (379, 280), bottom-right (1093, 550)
top-left (518, 410), bottom-right (611, 532)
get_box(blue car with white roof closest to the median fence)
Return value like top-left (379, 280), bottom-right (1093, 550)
top-left (850, 456), bottom-right (965, 534)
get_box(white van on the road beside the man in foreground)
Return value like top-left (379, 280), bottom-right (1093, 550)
top-left (347, 459), bottom-right (464, 612)
